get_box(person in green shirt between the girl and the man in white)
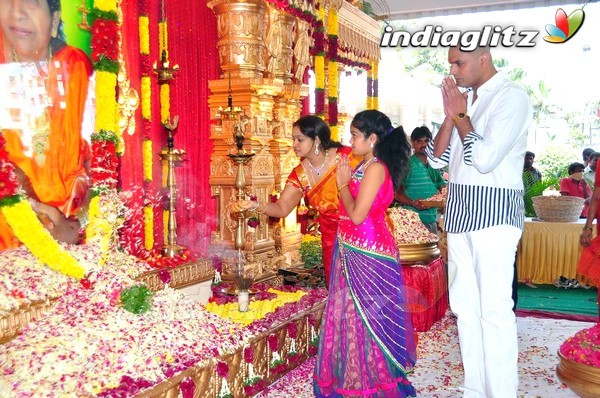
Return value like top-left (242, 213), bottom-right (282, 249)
top-left (395, 126), bottom-right (446, 233)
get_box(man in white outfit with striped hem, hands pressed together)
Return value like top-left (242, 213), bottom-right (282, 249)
top-left (428, 47), bottom-right (532, 398)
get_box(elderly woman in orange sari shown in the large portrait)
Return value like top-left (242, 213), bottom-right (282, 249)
top-left (0, 0), bottom-right (92, 250)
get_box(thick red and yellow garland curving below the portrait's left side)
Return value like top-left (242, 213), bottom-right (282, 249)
top-left (0, 133), bottom-right (87, 279)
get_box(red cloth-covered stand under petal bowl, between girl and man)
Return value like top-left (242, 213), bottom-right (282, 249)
top-left (402, 257), bottom-right (449, 332)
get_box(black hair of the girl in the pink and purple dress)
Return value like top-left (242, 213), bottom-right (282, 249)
top-left (352, 109), bottom-right (410, 190)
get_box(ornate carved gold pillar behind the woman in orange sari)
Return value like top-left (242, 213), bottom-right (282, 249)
top-left (208, 0), bottom-right (308, 280)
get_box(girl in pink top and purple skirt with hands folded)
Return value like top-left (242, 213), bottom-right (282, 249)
top-left (313, 110), bottom-right (416, 397)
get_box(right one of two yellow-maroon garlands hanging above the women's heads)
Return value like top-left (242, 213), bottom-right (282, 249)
top-left (327, 9), bottom-right (340, 141)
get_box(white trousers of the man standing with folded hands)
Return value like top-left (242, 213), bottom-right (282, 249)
top-left (448, 225), bottom-right (522, 398)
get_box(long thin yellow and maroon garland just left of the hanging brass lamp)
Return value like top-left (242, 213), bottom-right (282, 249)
top-left (139, 0), bottom-right (154, 250)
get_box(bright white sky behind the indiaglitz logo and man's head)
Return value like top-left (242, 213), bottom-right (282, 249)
top-left (370, 2), bottom-right (600, 148)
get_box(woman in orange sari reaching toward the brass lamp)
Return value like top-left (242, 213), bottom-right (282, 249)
top-left (232, 115), bottom-right (359, 286)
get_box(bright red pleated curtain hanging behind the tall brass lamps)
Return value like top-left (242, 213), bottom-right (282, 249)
top-left (120, 0), bottom-right (219, 255)
